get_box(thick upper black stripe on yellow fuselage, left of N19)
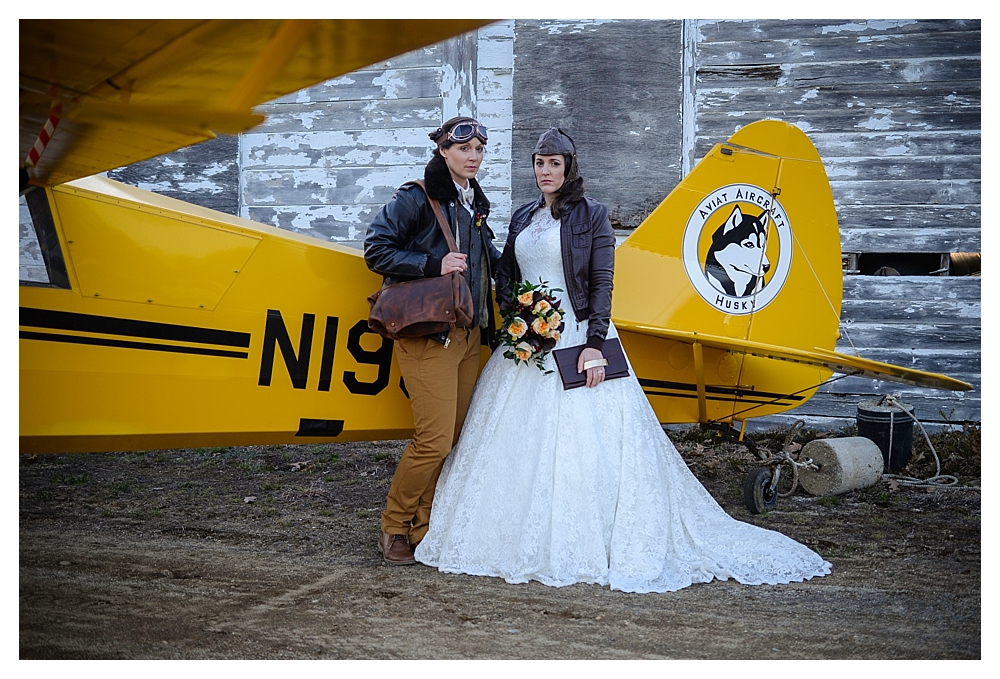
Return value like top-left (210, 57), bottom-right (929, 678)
top-left (20, 307), bottom-right (250, 348)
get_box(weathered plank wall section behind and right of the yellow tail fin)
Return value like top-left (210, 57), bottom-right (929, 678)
top-left (685, 20), bottom-right (982, 428)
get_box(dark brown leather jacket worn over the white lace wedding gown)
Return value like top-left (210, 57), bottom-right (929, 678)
top-left (496, 196), bottom-right (615, 349)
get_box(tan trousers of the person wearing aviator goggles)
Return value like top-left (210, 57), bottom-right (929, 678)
top-left (382, 328), bottom-right (480, 544)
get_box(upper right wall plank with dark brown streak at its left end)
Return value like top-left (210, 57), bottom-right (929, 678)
top-left (697, 58), bottom-right (982, 88)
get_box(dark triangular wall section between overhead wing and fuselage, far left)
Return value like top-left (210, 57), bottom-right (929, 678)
top-left (108, 135), bottom-right (239, 215)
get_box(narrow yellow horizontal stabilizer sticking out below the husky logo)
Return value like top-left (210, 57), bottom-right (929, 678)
top-left (612, 319), bottom-right (972, 391)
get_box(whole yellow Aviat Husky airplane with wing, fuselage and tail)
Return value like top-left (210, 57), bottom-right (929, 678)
top-left (18, 20), bottom-right (971, 462)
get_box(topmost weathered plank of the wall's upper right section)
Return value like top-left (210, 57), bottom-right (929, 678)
top-left (697, 19), bottom-right (981, 43)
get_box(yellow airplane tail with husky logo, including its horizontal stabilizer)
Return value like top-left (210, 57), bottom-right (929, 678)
top-left (612, 120), bottom-right (971, 423)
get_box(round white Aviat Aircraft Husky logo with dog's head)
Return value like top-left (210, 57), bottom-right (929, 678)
top-left (683, 184), bottom-right (792, 316)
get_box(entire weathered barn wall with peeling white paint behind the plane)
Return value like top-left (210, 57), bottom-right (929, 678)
top-left (66, 20), bottom-right (982, 428)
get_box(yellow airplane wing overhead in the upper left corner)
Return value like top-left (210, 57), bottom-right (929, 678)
top-left (18, 19), bottom-right (490, 186)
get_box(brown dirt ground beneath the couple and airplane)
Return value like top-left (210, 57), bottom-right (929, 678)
top-left (19, 428), bottom-right (981, 659)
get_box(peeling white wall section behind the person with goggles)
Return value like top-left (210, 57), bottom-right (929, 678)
top-left (240, 25), bottom-right (513, 246)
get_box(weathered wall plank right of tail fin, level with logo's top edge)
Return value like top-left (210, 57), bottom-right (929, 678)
top-left (830, 179), bottom-right (981, 208)
